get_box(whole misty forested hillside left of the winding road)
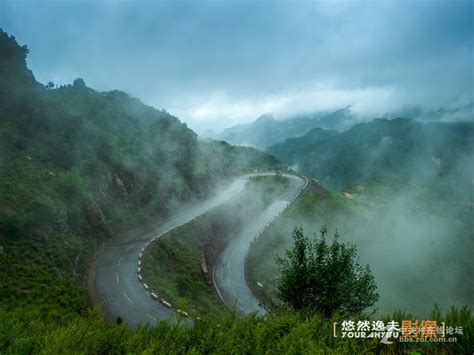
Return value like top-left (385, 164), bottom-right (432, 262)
top-left (0, 32), bottom-right (283, 318)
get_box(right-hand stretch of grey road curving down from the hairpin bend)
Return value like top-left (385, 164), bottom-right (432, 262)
top-left (214, 174), bottom-right (305, 314)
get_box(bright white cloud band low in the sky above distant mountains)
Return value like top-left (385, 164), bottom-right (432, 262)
top-left (169, 85), bottom-right (401, 131)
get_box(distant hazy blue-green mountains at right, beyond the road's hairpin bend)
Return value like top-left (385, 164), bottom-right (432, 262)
top-left (267, 118), bottom-right (474, 193)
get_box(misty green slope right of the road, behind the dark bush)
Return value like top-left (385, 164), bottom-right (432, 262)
top-left (246, 177), bottom-right (474, 315)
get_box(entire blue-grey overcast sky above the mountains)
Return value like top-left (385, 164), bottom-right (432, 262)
top-left (0, 0), bottom-right (474, 131)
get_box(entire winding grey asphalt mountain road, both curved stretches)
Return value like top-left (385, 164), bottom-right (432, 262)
top-left (90, 173), bottom-right (305, 327)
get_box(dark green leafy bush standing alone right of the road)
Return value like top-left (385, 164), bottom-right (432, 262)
top-left (276, 226), bottom-right (379, 317)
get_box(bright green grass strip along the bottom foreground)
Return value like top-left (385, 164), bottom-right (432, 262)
top-left (0, 308), bottom-right (474, 354)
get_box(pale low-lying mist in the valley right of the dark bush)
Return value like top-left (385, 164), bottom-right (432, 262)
top-left (343, 189), bottom-right (474, 315)
